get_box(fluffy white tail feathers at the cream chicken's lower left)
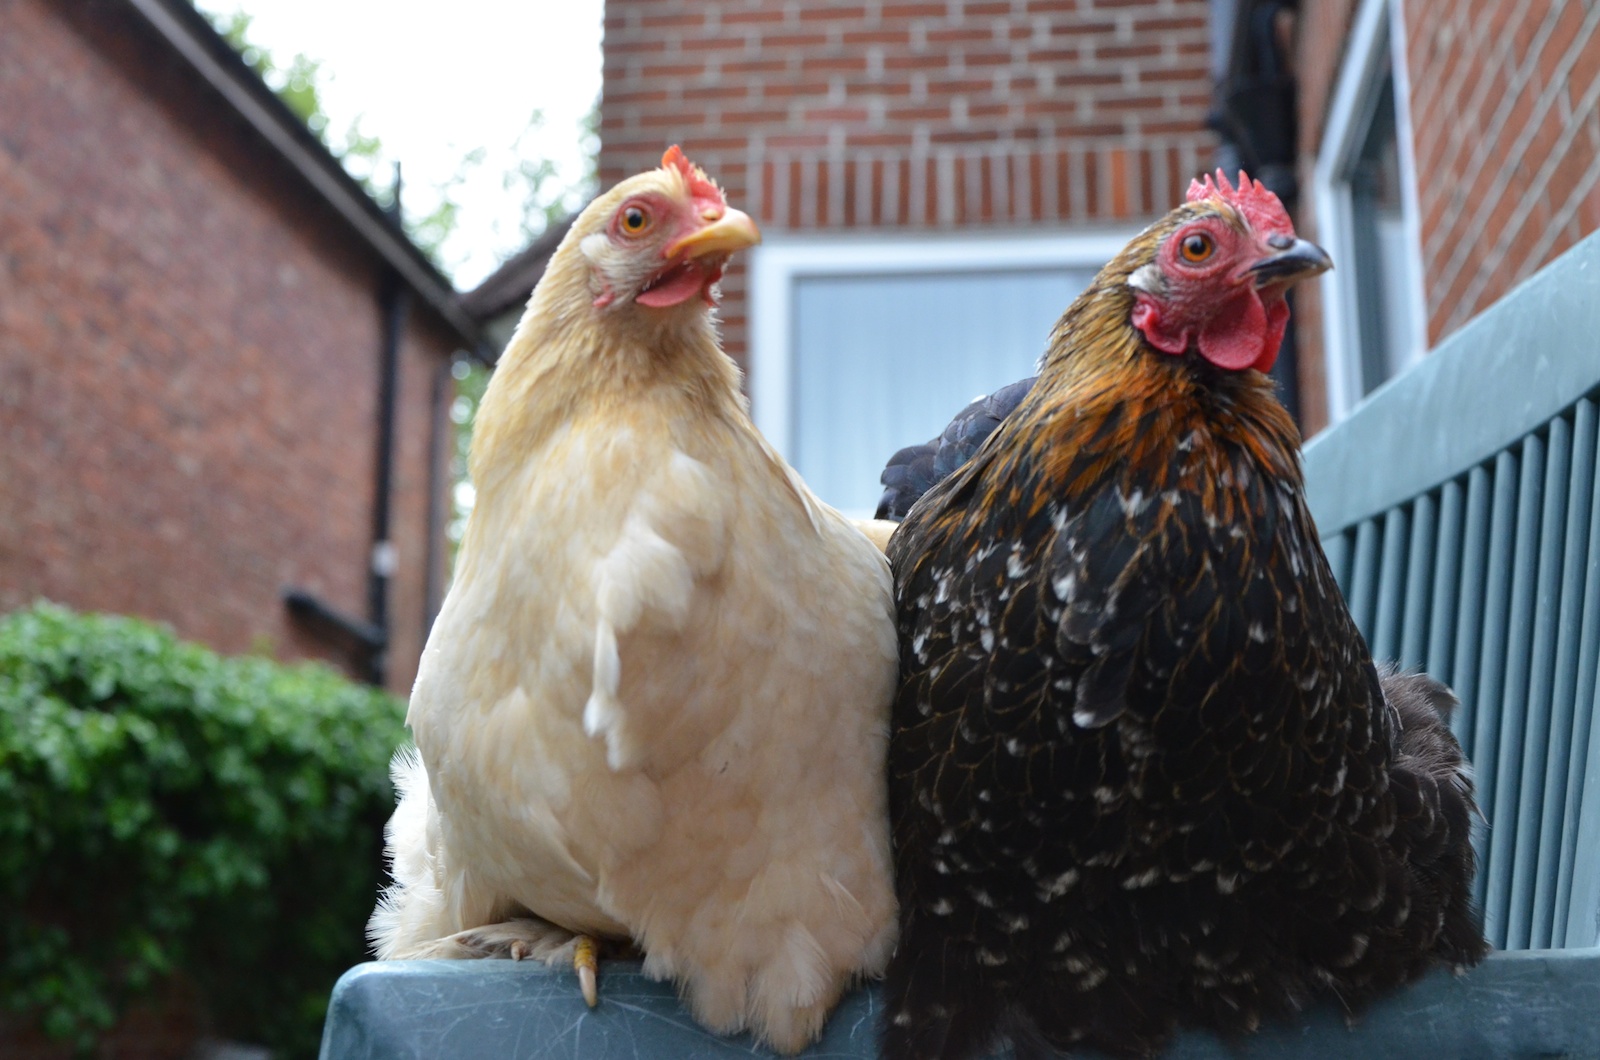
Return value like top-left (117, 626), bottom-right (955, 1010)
top-left (366, 745), bottom-right (448, 961)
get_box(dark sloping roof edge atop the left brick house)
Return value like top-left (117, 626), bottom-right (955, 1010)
top-left (126, 0), bottom-right (482, 349)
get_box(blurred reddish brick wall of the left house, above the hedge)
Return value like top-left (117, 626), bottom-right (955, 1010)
top-left (0, 0), bottom-right (451, 692)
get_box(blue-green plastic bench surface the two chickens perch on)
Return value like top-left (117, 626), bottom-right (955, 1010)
top-left (322, 950), bottom-right (1600, 1060)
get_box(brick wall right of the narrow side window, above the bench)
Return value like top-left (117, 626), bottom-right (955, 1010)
top-left (1405, 0), bottom-right (1600, 343)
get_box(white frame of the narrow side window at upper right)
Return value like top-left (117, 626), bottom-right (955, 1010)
top-left (1312, 0), bottom-right (1427, 423)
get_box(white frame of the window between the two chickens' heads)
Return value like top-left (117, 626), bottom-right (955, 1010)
top-left (749, 229), bottom-right (1138, 460)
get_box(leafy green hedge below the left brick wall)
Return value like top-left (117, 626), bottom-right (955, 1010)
top-left (0, 605), bottom-right (403, 1057)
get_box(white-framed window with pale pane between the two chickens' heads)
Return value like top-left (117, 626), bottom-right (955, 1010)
top-left (750, 232), bottom-right (1131, 516)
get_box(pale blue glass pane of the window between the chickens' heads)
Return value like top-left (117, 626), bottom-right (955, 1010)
top-left (789, 269), bottom-right (1094, 514)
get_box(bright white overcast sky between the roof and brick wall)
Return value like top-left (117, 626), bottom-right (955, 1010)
top-left (198, 0), bottom-right (602, 290)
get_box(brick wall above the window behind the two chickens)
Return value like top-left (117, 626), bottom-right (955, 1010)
top-left (600, 0), bottom-right (1214, 369)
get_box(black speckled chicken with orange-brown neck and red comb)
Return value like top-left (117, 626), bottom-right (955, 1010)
top-left (883, 173), bottom-right (1486, 1060)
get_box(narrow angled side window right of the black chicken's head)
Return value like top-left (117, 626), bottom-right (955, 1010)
top-left (1315, 0), bottom-right (1427, 420)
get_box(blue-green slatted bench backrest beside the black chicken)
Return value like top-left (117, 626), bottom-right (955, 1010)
top-left (1306, 230), bottom-right (1600, 950)
